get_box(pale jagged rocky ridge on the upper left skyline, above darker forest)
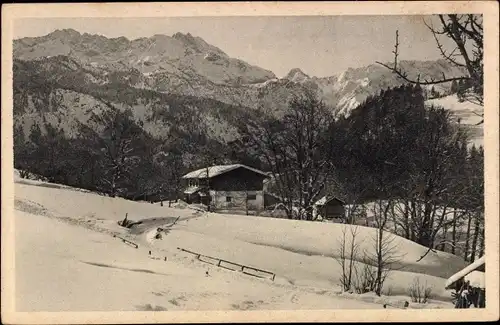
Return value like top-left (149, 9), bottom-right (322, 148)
top-left (14, 29), bottom-right (275, 85)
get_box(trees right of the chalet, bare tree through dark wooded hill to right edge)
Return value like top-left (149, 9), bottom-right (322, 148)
top-left (241, 84), bottom-right (484, 253)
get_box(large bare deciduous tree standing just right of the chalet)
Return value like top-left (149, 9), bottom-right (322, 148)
top-left (241, 93), bottom-right (333, 220)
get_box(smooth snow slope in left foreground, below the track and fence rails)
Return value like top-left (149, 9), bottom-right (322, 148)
top-left (15, 211), bottom-right (382, 312)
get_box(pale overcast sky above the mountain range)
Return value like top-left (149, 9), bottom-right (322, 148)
top-left (13, 16), bottom-right (450, 77)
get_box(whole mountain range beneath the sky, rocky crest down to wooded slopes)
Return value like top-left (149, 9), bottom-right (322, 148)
top-left (13, 29), bottom-right (480, 146)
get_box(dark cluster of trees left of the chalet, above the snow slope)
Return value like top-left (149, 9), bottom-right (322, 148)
top-left (14, 103), bottom-right (183, 199)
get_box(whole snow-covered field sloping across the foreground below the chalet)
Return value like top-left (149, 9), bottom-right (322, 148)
top-left (15, 172), bottom-right (465, 311)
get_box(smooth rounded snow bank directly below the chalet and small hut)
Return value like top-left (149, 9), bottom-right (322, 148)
top-left (178, 213), bottom-right (466, 278)
